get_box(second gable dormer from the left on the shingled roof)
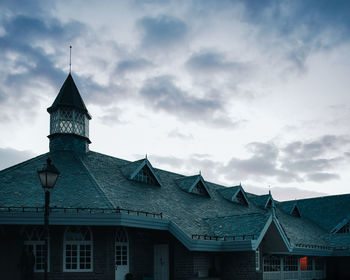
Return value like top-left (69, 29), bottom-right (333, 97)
top-left (175, 174), bottom-right (210, 197)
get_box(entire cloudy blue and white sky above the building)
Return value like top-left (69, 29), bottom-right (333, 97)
top-left (0, 0), bottom-right (350, 200)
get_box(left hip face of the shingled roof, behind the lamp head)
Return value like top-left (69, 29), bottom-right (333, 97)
top-left (0, 151), bottom-right (113, 208)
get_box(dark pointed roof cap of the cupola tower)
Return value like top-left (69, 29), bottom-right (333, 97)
top-left (47, 73), bottom-right (91, 118)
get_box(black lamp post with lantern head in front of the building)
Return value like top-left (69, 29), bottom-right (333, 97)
top-left (38, 158), bottom-right (60, 280)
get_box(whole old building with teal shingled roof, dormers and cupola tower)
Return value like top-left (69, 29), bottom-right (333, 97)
top-left (0, 74), bottom-right (350, 280)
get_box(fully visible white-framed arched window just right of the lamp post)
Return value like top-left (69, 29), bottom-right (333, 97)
top-left (63, 226), bottom-right (93, 272)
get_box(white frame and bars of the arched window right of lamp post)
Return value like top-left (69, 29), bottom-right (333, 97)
top-left (63, 227), bottom-right (94, 272)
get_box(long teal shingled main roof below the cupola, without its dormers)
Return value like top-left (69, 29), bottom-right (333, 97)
top-left (0, 151), bottom-right (350, 250)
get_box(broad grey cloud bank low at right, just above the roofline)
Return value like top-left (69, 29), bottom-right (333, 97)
top-left (220, 135), bottom-right (350, 182)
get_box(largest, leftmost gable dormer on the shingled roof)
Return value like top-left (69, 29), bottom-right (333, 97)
top-left (122, 158), bottom-right (161, 187)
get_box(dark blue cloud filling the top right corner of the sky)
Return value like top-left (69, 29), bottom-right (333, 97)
top-left (237, 0), bottom-right (350, 40)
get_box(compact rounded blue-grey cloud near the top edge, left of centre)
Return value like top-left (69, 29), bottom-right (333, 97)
top-left (136, 15), bottom-right (188, 48)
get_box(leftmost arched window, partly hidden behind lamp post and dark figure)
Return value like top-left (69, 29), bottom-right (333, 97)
top-left (23, 227), bottom-right (50, 272)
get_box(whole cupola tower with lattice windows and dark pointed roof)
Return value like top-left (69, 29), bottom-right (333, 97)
top-left (47, 73), bottom-right (91, 153)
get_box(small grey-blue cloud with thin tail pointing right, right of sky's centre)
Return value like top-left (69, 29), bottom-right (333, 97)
top-left (186, 51), bottom-right (246, 73)
